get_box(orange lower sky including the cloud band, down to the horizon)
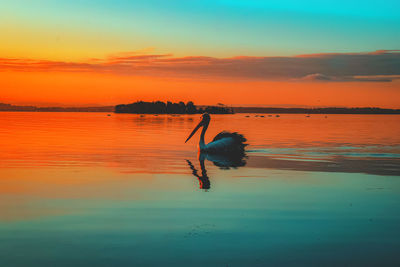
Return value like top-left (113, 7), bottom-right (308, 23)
top-left (0, 49), bottom-right (400, 108)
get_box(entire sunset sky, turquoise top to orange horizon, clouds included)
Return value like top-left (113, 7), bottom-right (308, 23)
top-left (0, 0), bottom-right (400, 108)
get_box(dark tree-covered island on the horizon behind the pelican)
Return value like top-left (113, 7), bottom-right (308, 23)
top-left (115, 101), bottom-right (233, 114)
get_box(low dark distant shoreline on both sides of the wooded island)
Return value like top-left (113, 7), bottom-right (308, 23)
top-left (0, 103), bottom-right (400, 115)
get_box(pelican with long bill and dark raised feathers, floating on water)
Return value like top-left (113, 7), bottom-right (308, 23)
top-left (185, 113), bottom-right (247, 154)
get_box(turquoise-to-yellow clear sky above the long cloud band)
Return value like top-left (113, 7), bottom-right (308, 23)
top-left (0, 0), bottom-right (400, 57)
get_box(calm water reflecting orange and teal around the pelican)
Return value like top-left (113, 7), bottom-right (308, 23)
top-left (0, 112), bottom-right (400, 266)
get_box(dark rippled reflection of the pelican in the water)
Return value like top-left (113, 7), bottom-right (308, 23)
top-left (186, 152), bottom-right (247, 191)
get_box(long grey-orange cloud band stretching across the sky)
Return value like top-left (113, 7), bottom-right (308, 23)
top-left (0, 50), bottom-right (400, 82)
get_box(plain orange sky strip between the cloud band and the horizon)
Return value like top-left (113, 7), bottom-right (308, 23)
top-left (0, 71), bottom-right (400, 108)
